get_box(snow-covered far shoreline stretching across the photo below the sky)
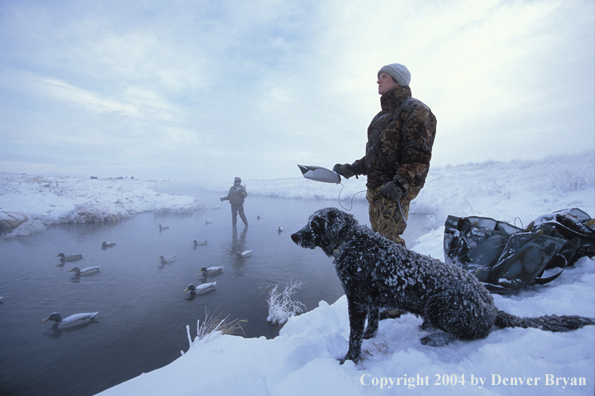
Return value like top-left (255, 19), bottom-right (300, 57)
top-left (0, 151), bottom-right (595, 236)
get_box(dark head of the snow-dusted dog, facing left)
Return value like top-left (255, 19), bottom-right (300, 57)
top-left (291, 208), bottom-right (357, 256)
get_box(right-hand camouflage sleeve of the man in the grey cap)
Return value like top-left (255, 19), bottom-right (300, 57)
top-left (393, 102), bottom-right (436, 190)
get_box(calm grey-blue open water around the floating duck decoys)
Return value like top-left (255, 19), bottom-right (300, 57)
top-left (0, 187), bottom-right (427, 396)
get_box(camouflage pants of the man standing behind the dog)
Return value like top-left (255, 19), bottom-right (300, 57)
top-left (366, 187), bottom-right (421, 246)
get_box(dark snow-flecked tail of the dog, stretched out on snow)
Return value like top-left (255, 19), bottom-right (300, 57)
top-left (495, 311), bottom-right (595, 332)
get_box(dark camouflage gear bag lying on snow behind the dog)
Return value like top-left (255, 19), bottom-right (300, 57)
top-left (444, 208), bottom-right (595, 294)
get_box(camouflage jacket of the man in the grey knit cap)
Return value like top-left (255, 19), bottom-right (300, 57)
top-left (352, 87), bottom-right (436, 190)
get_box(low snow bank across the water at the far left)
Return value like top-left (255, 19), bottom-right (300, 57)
top-left (0, 173), bottom-right (204, 236)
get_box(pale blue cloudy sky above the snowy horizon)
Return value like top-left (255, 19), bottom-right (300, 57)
top-left (0, 0), bottom-right (595, 186)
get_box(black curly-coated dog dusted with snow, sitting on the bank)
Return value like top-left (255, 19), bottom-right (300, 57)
top-left (291, 208), bottom-right (595, 362)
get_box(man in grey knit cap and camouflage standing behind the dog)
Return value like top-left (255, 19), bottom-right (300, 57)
top-left (333, 63), bottom-right (436, 246)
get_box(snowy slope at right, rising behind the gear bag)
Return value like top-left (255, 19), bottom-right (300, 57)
top-left (412, 151), bottom-right (595, 226)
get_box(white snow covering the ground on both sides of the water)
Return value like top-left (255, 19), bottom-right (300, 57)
top-left (0, 152), bottom-right (595, 396)
